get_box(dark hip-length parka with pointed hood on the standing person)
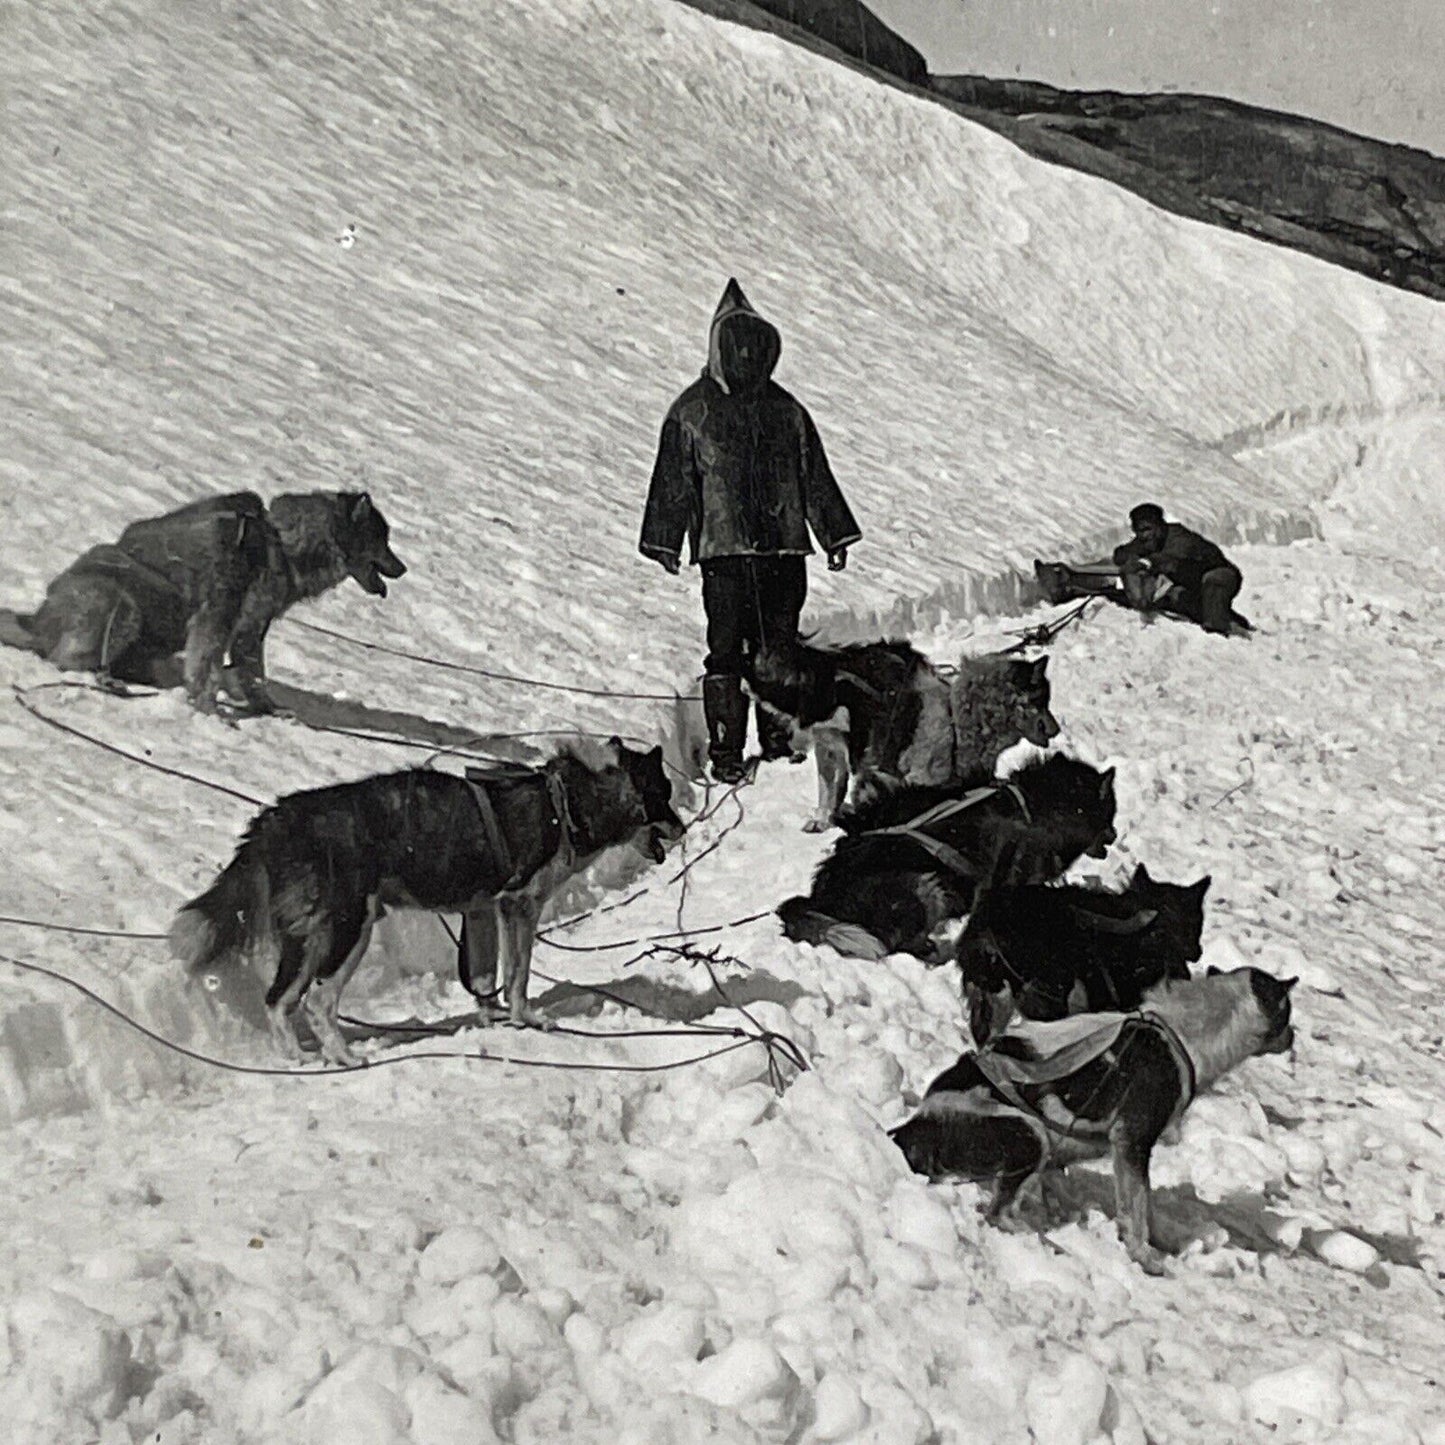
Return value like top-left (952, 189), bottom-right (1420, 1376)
top-left (637, 280), bottom-right (863, 562)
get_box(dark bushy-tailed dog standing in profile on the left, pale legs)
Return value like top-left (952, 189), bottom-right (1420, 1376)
top-left (171, 738), bottom-right (682, 1061)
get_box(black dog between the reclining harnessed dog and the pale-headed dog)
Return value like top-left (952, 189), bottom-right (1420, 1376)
top-left (957, 863), bottom-right (1209, 1048)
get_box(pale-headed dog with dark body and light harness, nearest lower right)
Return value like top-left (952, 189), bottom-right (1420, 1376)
top-left (892, 968), bottom-right (1296, 1273)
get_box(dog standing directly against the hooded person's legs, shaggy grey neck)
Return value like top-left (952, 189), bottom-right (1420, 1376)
top-left (744, 642), bottom-right (1059, 832)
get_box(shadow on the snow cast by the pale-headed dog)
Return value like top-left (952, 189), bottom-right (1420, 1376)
top-left (1052, 1169), bottom-right (1425, 1289)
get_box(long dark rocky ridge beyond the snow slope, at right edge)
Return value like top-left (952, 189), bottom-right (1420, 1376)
top-left (931, 75), bottom-right (1445, 301)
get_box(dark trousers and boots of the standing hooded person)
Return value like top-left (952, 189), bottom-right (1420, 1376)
top-left (702, 556), bottom-right (808, 762)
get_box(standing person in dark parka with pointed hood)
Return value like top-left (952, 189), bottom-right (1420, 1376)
top-left (637, 280), bottom-right (863, 783)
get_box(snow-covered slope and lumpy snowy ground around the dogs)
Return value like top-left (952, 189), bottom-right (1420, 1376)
top-left (0, 0), bottom-right (1445, 1445)
